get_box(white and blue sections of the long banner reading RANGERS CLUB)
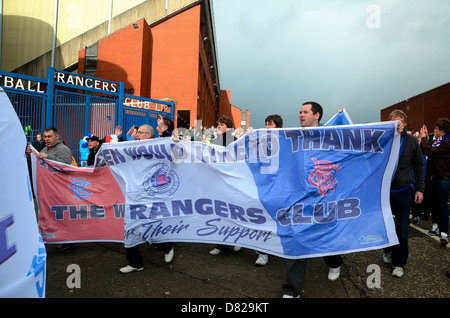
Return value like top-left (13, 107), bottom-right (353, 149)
top-left (97, 122), bottom-right (399, 258)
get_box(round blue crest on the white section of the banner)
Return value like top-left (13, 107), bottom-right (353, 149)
top-left (143, 163), bottom-right (180, 199)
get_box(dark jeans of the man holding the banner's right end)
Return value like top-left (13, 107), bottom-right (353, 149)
top-left (384, 188), bottom-right (413, 267)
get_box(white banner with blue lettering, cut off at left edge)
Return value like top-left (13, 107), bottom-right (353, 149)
top-left (0, 88), bottom-right (47, 298)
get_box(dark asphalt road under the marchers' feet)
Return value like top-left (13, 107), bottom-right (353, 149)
top-left (41, 214), bottom-right (450, 300)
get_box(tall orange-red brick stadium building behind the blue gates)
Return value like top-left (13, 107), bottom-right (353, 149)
top-left (78, 2), bottom-right (249, 128)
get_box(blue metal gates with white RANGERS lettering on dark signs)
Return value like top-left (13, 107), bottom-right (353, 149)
top-left (0, 67), bottom-right (174, 162)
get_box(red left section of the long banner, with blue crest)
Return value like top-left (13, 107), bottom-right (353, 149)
top-left (32, 149), bottom-right (125, 243)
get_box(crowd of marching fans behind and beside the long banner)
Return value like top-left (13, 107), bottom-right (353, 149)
top-left (27, 106), bottom-right (450, 297)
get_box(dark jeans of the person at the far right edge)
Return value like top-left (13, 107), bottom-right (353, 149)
top-left (429, 178), bottom-right (450, 234)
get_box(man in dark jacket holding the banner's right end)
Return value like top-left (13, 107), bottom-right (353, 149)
top-left (383, 110), bottom-right (425, 277)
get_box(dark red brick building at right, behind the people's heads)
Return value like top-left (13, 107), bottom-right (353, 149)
top-left (381, 83), bottom-right (450, 132)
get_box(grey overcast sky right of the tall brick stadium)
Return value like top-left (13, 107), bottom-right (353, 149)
top-left (212, 0), bottom-right (450, 128)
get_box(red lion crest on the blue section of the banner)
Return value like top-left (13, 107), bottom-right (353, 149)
top-left (308, 158), bottom-right (341, 197)
